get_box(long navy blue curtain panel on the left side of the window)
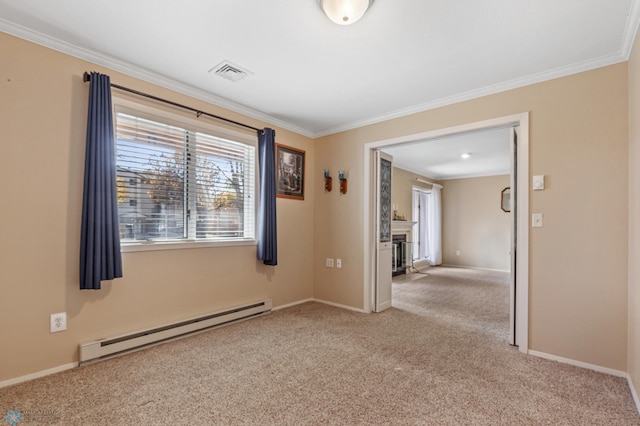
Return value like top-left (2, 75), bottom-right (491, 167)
top-left (80, 72), bottom-right (122, 290)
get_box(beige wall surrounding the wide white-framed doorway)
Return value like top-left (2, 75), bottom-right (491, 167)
top-left (314, 63), bottom-right (628, 371)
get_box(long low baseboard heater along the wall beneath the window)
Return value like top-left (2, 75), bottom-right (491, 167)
top-left (80, 299), bottom-right (271, 364)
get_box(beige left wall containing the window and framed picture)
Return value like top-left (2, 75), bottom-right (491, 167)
top-left (0, 33), bottom-right (316, 381)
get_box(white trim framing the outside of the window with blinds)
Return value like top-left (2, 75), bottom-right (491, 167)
top-left (112, 96), bottom-right (260, 253)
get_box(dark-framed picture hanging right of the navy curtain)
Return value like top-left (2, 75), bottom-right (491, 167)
top-left (276, 144), bottom-right (304, 200)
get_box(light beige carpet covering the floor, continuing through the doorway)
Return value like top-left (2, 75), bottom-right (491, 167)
top-left (0, 268), bottom-right (640, 425)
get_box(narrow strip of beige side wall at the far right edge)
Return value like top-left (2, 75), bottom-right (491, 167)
top-left (627, 25), bottom-right (640, 397)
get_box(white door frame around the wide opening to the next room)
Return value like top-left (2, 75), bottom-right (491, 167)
top-left (363, 112), bottom-right (529, 353)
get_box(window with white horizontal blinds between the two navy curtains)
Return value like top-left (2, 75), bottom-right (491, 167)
top-left (115, 108), bottom-right (256, 246)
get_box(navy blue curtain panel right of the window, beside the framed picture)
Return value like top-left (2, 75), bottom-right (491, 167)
top-left (258, 128), bottom-right (278, 266)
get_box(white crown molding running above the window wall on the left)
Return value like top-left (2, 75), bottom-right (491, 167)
top-left (0, 18), bottom-right (313, 138)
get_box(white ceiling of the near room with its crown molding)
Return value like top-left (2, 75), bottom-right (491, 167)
top-left (0, 0), bottom-right (640, 177)
